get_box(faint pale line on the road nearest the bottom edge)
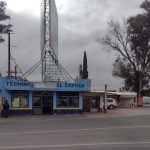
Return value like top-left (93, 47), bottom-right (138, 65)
top-left (0, 141), bottom-right (150, 149)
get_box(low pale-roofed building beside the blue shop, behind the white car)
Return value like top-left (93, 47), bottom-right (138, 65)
top-left (81, 91), bottom-right (137, 112)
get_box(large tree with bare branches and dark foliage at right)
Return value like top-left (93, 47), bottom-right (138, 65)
top-left (98, 0), bottom-right (150, 101)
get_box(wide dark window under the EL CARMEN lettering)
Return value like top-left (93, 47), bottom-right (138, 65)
top-left (57, 96), bottom-right (79, 108)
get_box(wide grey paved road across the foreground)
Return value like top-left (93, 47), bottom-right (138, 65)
top-left (0, 108), bottom-right (150, 150)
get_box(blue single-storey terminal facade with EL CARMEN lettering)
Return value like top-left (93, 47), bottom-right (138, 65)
top-left (0, 77), bottom-right (91, 114)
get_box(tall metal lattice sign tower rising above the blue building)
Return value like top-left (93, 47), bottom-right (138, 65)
top-left (41, 0), bottom-right (73, 82)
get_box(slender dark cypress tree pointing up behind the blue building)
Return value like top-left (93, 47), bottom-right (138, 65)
top-left (82, 51), bottom-right (88, 79)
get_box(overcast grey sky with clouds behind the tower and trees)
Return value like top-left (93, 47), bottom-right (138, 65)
top-left (0, 0), bottom-right (144, 90)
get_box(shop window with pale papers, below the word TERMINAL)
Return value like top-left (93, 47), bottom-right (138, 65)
top-left (12, 91), bottom-right (29, 108)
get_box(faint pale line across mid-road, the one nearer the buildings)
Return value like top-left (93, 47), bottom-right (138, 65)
top-left (0, 126), bottom-right (150, 135)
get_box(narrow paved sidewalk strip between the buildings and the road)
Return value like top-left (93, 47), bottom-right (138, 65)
top-left (0, 106), bottom-right (150, 122)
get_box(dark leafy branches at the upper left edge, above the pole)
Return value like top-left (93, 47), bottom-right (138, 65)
top-left (0, 1), bottom-right (12, 43)
